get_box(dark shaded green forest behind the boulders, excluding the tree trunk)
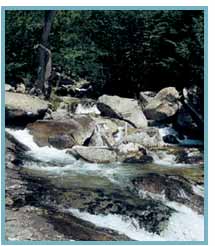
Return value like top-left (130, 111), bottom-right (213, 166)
top-left (6, 10), bottom-right (204, 97)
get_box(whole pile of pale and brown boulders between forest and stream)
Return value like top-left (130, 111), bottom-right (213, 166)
top-left (5, 84), bottom-right (203, 163)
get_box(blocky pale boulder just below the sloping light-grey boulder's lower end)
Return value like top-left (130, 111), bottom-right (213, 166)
top-left (125, 127), bottom-right (164, 147)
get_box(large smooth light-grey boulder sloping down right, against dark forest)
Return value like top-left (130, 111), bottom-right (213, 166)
top-left (98, 95), bottom-right (147, 127)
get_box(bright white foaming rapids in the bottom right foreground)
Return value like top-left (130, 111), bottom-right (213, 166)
top-left (69, 202), bottom-right (204, 241)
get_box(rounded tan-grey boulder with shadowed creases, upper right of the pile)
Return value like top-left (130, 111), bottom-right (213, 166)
top-left (143, 87), bottom-right (181, 121)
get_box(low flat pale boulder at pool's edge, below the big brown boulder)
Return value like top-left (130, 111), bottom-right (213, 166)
top-left (68, 146), bottom-right (117, 163)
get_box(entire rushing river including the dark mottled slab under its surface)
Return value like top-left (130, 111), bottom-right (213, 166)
top-left (6, 128), bottom-right (204, 241)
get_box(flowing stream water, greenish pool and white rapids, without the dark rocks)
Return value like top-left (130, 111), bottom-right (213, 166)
top-left (6, 129), bottom-right (204, 241)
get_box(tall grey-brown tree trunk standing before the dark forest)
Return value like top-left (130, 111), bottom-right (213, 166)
top-left (37, 10), bottom-right (56, 92)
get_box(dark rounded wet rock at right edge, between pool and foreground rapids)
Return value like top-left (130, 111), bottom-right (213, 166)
top-left (132, 173), bottom-right (204, 214)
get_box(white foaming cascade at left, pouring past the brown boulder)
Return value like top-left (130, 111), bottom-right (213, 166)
top-left (6, 128), bottom-right (75, 164)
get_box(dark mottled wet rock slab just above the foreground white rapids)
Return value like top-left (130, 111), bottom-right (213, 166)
top-left (41, 185), bottom-right (175, 234)
